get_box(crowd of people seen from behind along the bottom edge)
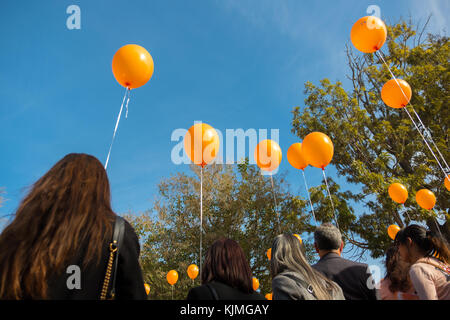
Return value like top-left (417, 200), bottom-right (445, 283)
top-left (0, 154), bottom-right (450, 300)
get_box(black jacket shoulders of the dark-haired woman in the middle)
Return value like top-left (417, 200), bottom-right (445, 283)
top-left (187, 281), bottom-right (265, 300)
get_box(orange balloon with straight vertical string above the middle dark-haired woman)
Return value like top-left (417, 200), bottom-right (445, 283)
top-left (184, 123), bottom-right (220, 273)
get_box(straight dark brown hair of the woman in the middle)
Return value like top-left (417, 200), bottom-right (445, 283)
top-left (201, 238), bottom-right (253, 293)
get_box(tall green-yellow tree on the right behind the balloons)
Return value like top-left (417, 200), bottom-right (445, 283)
top-left (292, 21), bottom-right (450, 258)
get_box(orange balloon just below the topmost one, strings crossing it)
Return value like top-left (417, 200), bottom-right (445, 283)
top-left (381, 79), bottom-right (412, 109)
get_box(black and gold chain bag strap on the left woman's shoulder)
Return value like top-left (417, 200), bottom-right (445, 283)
top-left (100, 216), bottom-right (125, 300)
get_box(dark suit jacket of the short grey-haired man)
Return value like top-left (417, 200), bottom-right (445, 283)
top-left (312, 252), bottom-right (377, 300)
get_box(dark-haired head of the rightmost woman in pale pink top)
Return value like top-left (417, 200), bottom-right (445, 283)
top-left (395, 224), bottom-right (450, 264)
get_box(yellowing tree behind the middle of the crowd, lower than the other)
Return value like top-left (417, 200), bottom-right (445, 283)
top-left (123, 160), bottom-right (314, 299)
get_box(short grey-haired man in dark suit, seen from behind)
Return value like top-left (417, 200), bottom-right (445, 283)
top-left (312, 223), bottom-right (377, 300)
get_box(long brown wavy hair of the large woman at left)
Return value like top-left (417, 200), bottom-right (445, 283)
top-left (0, 153), bottom-right (115, 299)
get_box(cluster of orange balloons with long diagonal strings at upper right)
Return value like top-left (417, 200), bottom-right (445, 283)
top-left (350, 16), bottom-right (450, 190)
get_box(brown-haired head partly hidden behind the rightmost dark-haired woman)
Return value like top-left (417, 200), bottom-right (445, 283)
top-left (385, 245), bottom-right (411, 292)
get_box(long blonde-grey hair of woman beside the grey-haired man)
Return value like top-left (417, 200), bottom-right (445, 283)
top-left (270, 234), bottom-right (337, 300)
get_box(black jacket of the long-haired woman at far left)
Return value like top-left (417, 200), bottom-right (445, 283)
top-left (48, 221), bottom-right (147, 300)
